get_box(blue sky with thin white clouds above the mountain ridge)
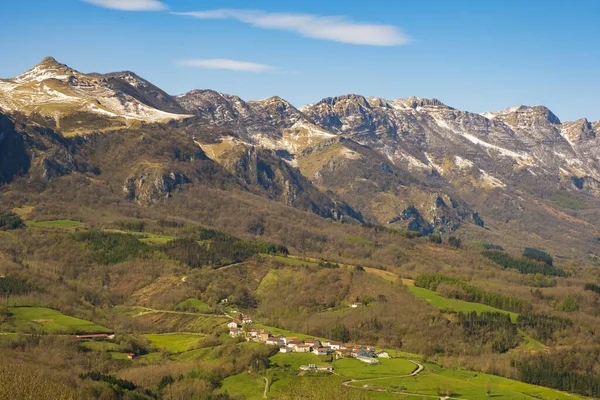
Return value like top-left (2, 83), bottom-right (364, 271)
top-left (0, 0), bottom-right (600, 121)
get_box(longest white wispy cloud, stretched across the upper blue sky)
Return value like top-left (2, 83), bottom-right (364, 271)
top-left (173, 9), bottom-right (410, 46)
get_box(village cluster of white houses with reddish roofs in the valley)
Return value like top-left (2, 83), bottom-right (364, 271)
top-left (228, 321), bottom-right (390, 364)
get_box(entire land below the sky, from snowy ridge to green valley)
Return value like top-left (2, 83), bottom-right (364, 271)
top-left (0, 57), bottom-right (600, 400)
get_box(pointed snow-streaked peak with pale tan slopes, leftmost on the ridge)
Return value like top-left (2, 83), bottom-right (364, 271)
top-left (0, 57), bottom-right (191, 135)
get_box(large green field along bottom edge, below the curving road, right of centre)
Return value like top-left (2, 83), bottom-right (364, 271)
top-left (355, 364), bottom-right (583, 400)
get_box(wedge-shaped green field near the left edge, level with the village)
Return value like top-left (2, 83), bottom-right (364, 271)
top-left (4, 307), bottom-right (110, 334)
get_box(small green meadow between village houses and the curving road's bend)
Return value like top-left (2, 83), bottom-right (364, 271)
top-left (333, 358), bottom-right (417, 379)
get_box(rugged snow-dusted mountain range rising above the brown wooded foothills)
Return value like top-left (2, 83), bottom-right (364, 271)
top-left (0, 57), bottom-right (600, 260)
